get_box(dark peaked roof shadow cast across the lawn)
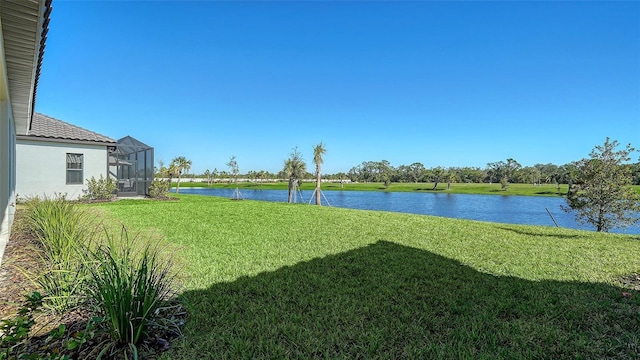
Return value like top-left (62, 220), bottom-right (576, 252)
top-left (169, 241), bottom-right (640, 359)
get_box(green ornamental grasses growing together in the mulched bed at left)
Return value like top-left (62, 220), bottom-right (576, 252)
top-left (8, 196), bottom-right (186, 359)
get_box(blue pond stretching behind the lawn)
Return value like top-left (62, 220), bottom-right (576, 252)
top-left (174, 188), bottom-right (640, 234)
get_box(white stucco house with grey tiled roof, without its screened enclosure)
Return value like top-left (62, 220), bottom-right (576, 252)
top-left (16, 113), bottom-right (117, 200)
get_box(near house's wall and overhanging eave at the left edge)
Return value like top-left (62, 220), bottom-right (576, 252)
top-left (0, 0), bottom-right (51, 261)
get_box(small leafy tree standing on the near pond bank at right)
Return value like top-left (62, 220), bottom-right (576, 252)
top-left (563, 138), bottom-right (640, 232)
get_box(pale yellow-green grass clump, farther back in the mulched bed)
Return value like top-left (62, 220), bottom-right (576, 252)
top-left (26, 195), bottom-right (95, 314)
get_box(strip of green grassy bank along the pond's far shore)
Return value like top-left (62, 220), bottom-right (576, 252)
top-left (174, 181), bottom-right (568, 196)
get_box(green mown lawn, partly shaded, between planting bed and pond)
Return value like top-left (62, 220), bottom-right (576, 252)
top-left (93, 195), bottom-right (640, 359)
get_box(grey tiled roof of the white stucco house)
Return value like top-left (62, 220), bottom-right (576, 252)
top-left (28, 112), bottom-right (116, 143)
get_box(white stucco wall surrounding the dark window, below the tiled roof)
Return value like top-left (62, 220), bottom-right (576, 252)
top-left (16, 139), bottom-right (107, 199)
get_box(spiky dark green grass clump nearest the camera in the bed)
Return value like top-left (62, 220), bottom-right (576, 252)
top-left (88, 227), bottom-right (179, 357)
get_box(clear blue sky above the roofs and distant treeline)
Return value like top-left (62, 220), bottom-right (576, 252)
top-left (36, 0), bottom-right (640, 173)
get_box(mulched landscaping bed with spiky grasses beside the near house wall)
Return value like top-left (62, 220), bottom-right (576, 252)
top-left (0, 199), bottom-right (187, 360)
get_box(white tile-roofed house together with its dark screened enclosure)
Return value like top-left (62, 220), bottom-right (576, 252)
top-left (16, 113), bottom-right (153, 200)
